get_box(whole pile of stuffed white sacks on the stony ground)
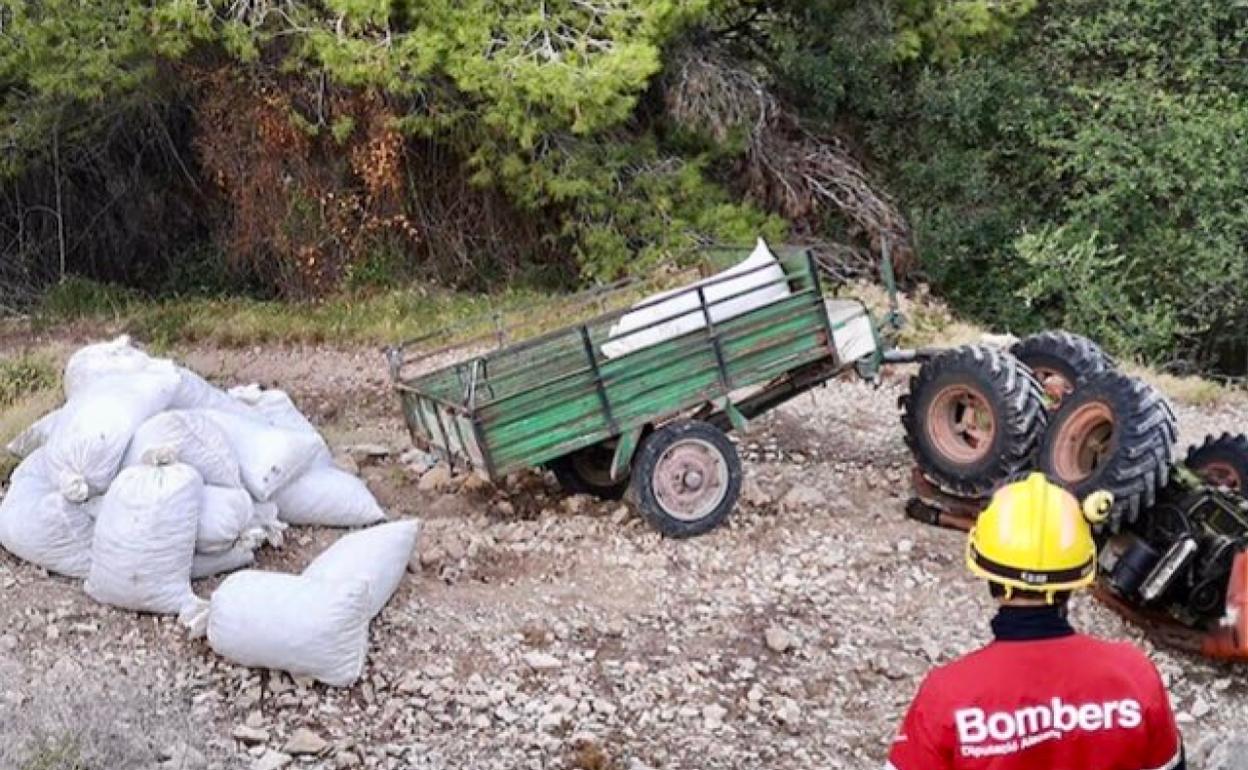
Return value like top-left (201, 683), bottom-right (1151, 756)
top-left (0, 337), bottom-right (419, 685)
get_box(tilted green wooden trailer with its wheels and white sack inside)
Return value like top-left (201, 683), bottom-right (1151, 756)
top-left (387, 250), bottom-right (885, 537)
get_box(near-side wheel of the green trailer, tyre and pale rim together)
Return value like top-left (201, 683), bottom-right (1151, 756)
top-left (629, 421), bottom-right (741, 538)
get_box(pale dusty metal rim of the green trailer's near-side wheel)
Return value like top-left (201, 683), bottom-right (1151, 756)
top-left (651, 438), bottom-right (729, 522)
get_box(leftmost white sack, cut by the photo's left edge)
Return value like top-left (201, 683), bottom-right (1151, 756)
top-left (0, 449), bottom-right (99, 578)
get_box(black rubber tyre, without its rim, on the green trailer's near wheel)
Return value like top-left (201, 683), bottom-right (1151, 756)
top-left (626, 419), bottom-right (743, 538)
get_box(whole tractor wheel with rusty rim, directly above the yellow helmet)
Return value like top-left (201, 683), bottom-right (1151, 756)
top-left (1036, 372), bottom-right (1178, 532)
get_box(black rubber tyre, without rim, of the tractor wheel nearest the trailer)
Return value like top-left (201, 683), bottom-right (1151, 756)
top-left (897, 344), bottom-right (1048, 498)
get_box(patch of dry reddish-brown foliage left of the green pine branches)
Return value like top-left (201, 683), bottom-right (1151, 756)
top-left (192, 69), bottom-right (419, 297)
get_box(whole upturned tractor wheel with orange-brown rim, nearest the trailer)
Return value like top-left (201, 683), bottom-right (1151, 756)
top-left (899, 346), bottom-right (1047, 498)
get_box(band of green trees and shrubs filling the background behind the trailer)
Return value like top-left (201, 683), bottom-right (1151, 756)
top-left (0, 0), bottom-right (1248, 374)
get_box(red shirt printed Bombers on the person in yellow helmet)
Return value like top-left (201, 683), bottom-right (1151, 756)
top-left (889, 634), bottom-right (1183, 770)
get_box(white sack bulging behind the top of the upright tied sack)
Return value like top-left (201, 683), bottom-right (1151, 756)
top-left (121, 411), bottom-right (242, 487)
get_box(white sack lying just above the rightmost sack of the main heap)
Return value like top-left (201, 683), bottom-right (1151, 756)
top-left (195, 409), bottom-right (322, 502)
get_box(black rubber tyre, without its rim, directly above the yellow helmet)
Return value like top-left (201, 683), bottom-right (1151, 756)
top-left (1036, 371), bottom-right (1178, 532)
